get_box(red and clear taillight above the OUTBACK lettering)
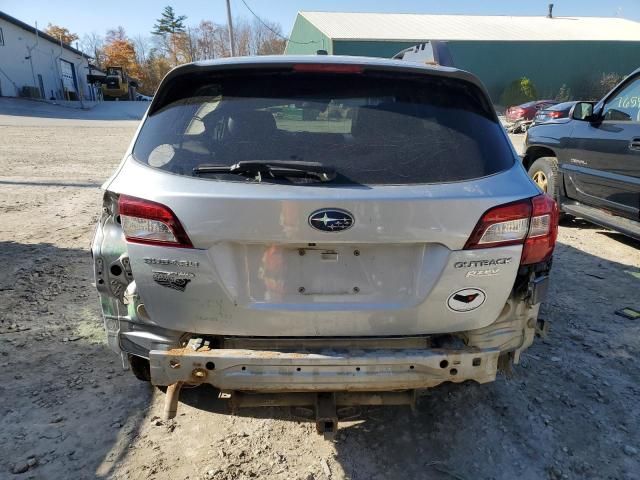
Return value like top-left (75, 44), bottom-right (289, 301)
top-left (464, 195), bottom-right (558, 265)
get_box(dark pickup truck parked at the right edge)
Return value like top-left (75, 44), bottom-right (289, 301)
top-left (523, 69), bottom-right (640, 239)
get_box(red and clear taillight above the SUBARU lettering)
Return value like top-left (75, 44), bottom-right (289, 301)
top-left (118, 195), bottom-right (193, 248)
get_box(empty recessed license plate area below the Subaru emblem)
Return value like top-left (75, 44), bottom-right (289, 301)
top-left (241, 245), bottom-right (422, 303)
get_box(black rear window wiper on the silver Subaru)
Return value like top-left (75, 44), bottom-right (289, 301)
top-left (193, 160), bottom-right (336, 182)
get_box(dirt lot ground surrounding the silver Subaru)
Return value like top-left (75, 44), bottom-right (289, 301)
top-left (0, 99), bottom-right (640, 480)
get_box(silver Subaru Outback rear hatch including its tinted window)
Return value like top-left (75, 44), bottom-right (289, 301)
top-left (108, 60), bottom-right (538, 336)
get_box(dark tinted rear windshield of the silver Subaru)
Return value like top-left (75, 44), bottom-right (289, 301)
top-left (133, 70), bottom-right (514, 185)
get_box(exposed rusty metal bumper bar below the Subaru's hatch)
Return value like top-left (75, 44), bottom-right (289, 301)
top-left (149, 346), bottom-right (500, 392)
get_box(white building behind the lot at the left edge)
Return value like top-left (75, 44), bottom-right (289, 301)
top-left (0, 11), bottom-right (94, 100)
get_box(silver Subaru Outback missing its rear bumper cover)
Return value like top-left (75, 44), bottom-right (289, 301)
top-left (92, 56), bottom-right (558, 436)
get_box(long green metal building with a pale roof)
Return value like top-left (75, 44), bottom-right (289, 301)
top-left (285, 12), bottom-right (640, 102)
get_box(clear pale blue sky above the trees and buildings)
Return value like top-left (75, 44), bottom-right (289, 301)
top-left (0, 0), bottom-right (640, 37)
